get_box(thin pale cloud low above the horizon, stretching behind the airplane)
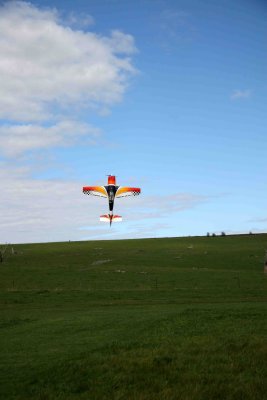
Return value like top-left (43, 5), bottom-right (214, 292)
top-left (0, 163), bottom-right (208, 243)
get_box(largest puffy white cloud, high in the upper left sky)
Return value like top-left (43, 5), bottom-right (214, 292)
top-left (0, 1), bottom-right (136, 122)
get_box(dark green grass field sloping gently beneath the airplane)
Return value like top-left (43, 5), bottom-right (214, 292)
top-left (0, 234), bottom-right (267, 400)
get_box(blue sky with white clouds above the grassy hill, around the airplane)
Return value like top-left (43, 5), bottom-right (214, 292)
top-left (0, 0), bottom-right (267, 243)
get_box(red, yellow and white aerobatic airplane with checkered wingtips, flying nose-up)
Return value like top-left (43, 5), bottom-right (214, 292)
top-left (83, 175), bottom-right (141, 226)
